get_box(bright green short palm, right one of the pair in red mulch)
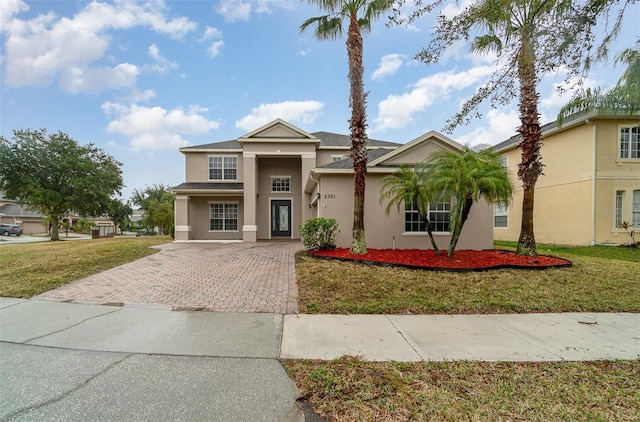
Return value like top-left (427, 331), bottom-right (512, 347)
top-left (426, 147), bottom-right (513, 258)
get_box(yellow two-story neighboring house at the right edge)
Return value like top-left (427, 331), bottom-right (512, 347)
top-left (493, 112), bottom-right (640, 245)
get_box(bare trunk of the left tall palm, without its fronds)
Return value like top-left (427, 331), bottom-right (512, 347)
top-left (347, 13), bottom-right (367, 254)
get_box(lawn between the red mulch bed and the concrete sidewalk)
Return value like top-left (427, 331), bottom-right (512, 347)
top-left (296, 252), bottom-right (640, 314)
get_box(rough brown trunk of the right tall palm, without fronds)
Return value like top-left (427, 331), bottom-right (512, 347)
top-left (516, 29), bottom-right (544, 256)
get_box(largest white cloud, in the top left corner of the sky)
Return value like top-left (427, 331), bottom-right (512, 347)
top-left (1, 0), bottom-right (196, 93)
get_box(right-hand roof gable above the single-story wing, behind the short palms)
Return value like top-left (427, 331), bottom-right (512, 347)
top-left (369, 130), bottom-right (464, 167)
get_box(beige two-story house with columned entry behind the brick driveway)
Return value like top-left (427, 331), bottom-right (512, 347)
top-left (173, 119), bottom-right (493, 249)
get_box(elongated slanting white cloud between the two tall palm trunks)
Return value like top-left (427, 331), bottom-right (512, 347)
top-left (374, 66), bottom-right (494, 131)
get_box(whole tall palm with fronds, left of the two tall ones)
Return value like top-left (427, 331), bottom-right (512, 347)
top-left (300, 0), bottom-right (394, 254)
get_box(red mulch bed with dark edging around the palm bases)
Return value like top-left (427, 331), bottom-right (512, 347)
top-left (309, 248), bottom-right (571, 272)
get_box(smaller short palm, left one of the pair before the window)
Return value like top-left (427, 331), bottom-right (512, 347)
top-left (380, 162), bottom-right (440, 256)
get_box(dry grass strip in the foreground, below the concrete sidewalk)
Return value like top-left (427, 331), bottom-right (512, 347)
top-left (283, 358), bottom-right (640, 421)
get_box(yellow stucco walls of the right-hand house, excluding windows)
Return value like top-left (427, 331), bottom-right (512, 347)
top-left (494, 119), bottom-right (640, 245)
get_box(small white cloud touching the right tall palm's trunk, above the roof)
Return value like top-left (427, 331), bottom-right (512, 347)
top-left (456, 109), bottom-right (520, 146)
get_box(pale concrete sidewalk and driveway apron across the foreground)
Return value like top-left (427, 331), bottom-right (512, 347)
top-left (0, 298), bottom-right (640, 421)
